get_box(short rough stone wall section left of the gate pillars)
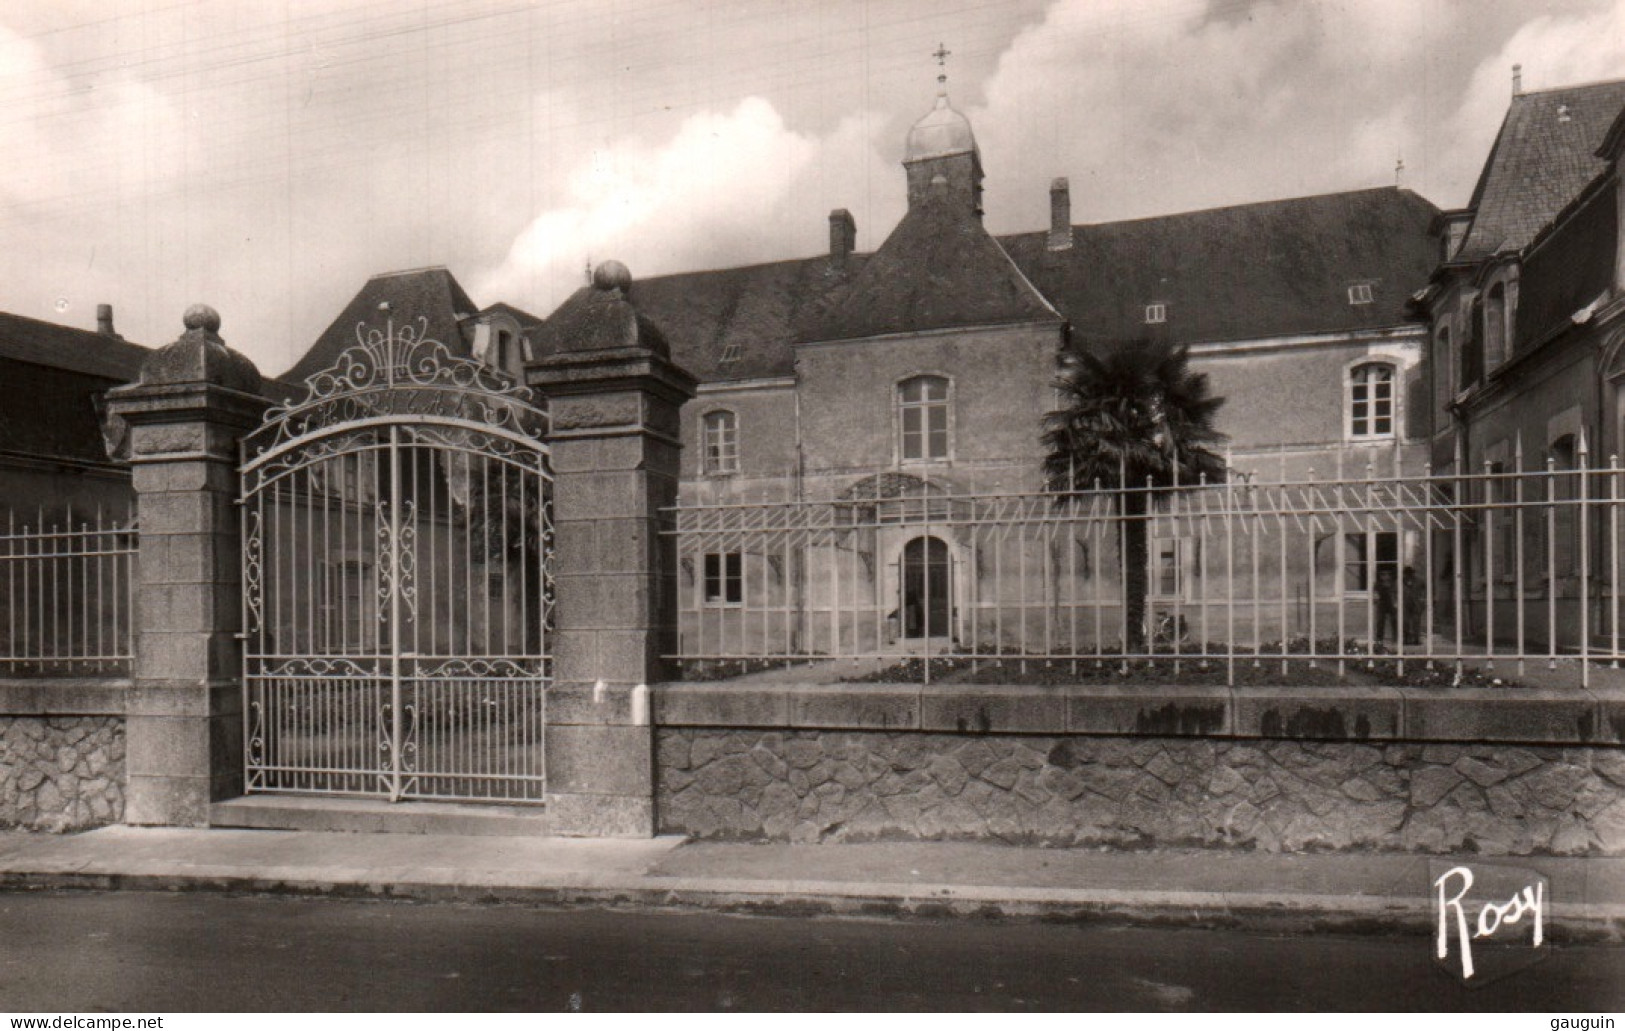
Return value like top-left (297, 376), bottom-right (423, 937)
top-left (0, 716), bottom-right (124, 831)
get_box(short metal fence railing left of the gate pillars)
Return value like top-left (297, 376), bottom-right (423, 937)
top-left (0, 509), bottom-right (137, 676)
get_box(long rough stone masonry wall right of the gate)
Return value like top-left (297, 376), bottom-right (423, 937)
top-left (657, 727), bottom-right (1625, 855)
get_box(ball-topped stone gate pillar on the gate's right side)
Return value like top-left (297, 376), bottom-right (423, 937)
top-left (528, 262), bottom-right (694, 837)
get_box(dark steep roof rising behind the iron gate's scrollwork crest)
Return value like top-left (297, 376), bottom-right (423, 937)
top-left (281, 267), bottom-right (477, 389)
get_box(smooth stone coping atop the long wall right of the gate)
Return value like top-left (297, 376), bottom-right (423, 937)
top-left (650, 681), bottom-right (1625, 745)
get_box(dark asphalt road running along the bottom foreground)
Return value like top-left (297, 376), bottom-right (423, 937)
top-left (0, 893), bottom-right (1625, 1015)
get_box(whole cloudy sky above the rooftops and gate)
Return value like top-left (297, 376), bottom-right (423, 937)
top-left (0, 0), bottom-right (1625, 376)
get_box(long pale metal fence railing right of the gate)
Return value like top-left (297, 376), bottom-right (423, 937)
top-left (668, 447), bottom-right (1625, 683)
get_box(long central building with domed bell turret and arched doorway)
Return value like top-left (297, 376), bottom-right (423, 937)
top-left (530, 86), bottom-right (1441, 657)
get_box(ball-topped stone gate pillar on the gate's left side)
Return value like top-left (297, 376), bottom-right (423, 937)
top-left (107, 304), bottom-right (270, 826)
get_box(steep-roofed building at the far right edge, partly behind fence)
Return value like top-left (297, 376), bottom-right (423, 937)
top-left (1415, 81), bottom-right (1625, 649)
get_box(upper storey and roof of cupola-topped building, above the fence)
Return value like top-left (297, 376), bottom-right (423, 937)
top-left (530, 80), bottom-right (1441, 499)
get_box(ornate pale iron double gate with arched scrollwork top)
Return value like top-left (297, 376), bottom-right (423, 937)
top-left (242, 320), bottom-right (553, 802)
